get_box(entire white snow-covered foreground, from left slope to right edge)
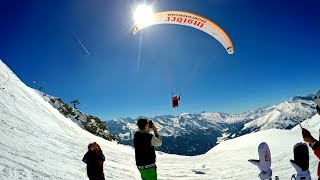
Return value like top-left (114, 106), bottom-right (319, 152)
top-left (0, 61), bottom-right (320, 180)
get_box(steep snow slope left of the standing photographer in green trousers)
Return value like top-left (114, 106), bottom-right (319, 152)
top-left (0, 61), bottom-right (138, 180)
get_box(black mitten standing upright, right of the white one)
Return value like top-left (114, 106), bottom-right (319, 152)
top-left (290, 143), bottom-right (311, 180)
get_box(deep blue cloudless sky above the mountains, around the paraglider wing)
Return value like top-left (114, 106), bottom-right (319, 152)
top-left (0, 0), bottom-right (320, 120)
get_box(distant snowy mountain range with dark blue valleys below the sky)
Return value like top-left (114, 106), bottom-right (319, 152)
top-left (106, 95), bottom-right (316, 156)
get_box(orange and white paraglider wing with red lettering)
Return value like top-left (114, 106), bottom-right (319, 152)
top-left (133, 11), bottom-right (234, 54)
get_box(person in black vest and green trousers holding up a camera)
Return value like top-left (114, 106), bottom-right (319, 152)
top-left (133, 119), bottom-right (162, 180)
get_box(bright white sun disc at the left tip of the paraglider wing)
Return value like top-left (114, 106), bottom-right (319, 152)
top-left (134, 5), bottom-right (153, 25)
